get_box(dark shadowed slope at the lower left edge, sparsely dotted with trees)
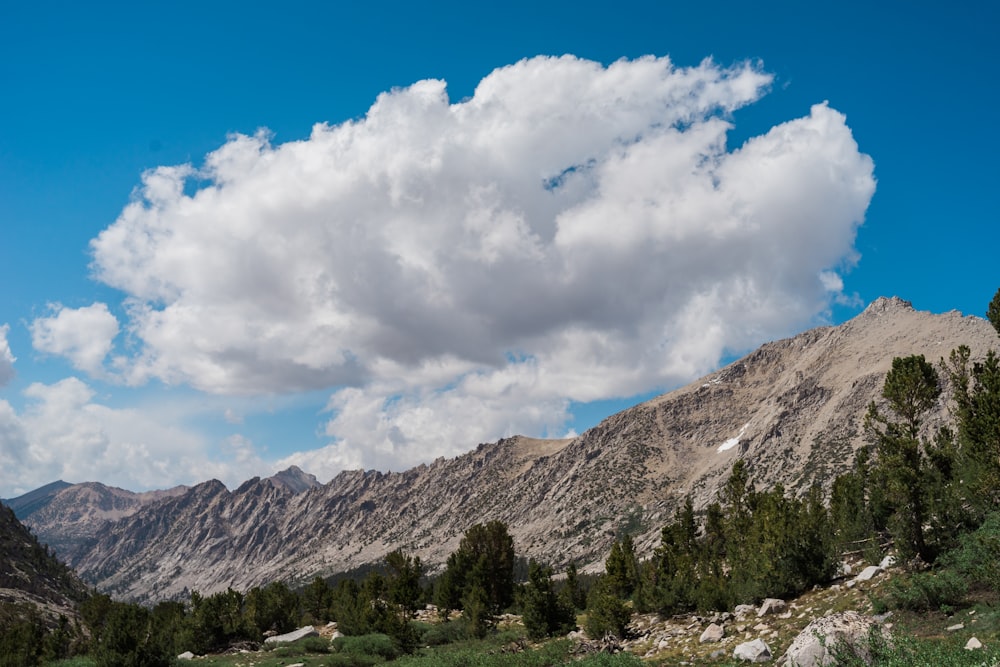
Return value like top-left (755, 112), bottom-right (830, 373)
top-left (0, 504), bottom-right (88, 627)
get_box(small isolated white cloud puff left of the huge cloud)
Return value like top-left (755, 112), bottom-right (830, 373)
top-left (31, 303), bottom-right (119, 376)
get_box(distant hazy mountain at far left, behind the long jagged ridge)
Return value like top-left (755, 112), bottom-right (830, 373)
top-left (4, 480), bottom-right (188, 562)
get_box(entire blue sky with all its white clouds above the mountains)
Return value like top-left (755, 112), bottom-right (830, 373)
top-left (0, 0), bottom-right (1000, 497)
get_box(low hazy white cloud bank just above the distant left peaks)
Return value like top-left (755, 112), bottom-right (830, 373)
top-left (0, 377), bottom-right (273, 497)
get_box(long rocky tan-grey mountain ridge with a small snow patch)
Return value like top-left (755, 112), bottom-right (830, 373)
top-left (66, 298), bottom-right (998, 601)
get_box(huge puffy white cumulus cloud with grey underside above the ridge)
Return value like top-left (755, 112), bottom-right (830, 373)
top-left (84, 56), bottom-right (875, 471)
